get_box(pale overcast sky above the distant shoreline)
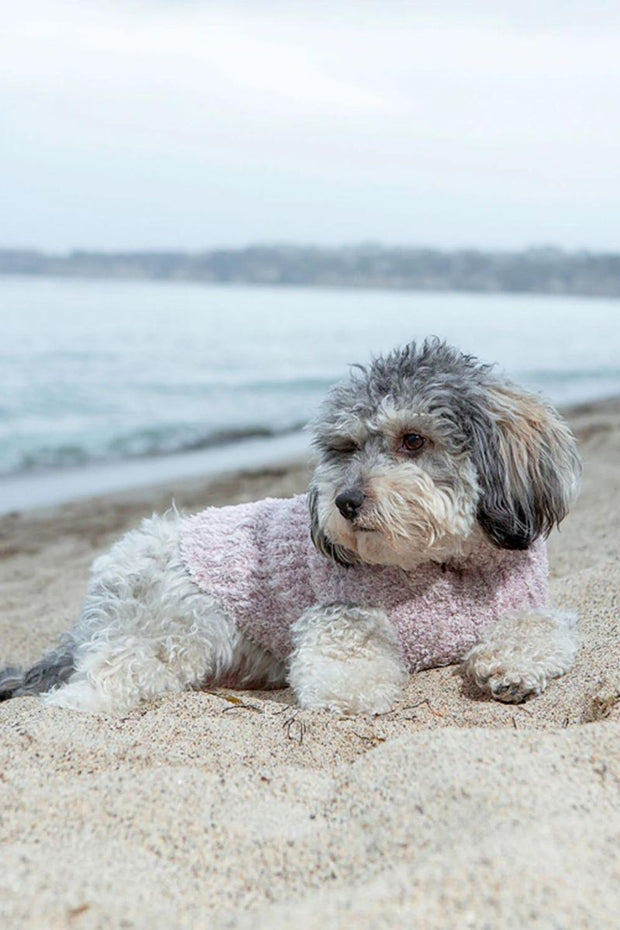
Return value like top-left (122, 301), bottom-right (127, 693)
top-left (0, 0), bottom-right (620, 251)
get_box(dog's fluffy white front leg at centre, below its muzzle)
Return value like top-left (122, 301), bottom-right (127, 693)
top-left (288, 604), bottom-right (407, 714)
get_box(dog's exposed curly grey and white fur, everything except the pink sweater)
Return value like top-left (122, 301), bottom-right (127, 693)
top-left (0, 339), bottom-right (579, 713)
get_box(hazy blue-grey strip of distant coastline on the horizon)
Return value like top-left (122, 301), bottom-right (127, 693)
top-left (0, 245), bottom-right (620, 297)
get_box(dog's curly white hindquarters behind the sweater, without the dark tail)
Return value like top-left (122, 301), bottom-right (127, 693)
top-left (41, 518), bottom-right (276, 713)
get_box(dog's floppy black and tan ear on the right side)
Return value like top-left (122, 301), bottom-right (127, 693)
top-left (472, 385), bottom-right (581, 549)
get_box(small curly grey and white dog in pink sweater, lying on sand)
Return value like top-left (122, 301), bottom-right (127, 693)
top-left (0, 338), bottom-right (580, 714)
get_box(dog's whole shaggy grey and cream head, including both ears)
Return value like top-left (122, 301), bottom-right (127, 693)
top-left (310, 340), bottom-right (579, 569)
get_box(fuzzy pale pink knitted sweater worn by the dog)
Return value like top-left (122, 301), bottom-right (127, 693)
top-left (181, 495), bottom-right (547, 671)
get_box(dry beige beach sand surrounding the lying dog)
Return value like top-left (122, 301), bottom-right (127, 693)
top-left (0, 401), bottom-right (620, 930)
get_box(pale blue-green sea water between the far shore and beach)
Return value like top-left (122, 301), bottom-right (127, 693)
top-left (0, 277), bottom-right (620, 508)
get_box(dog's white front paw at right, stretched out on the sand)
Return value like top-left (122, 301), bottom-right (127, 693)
top-left (463, 609), bottom-right (579, 704)
